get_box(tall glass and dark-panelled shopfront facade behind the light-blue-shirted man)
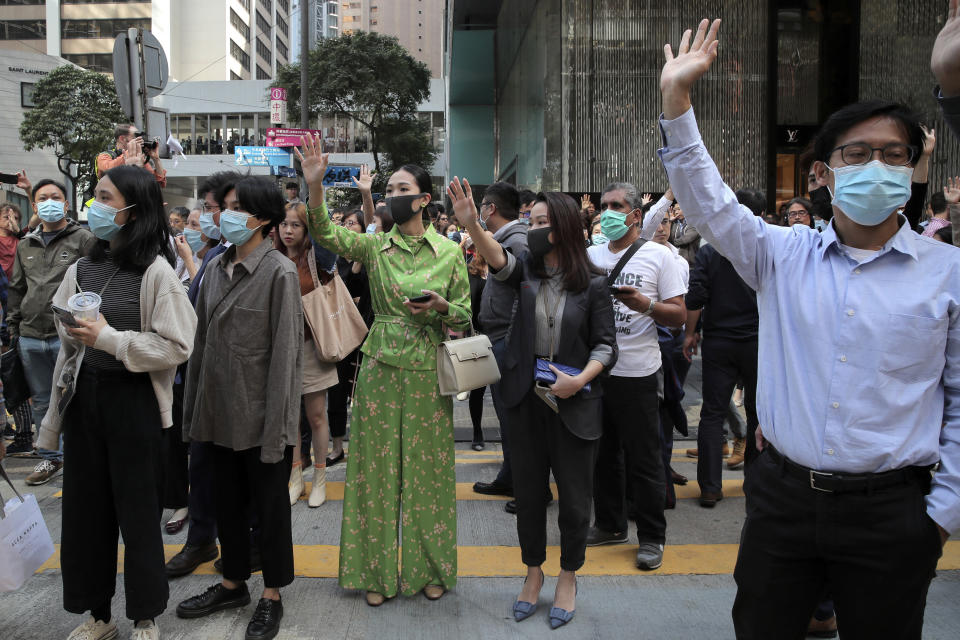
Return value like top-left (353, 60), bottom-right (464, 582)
top-left (447, 0), bottom-right (960, 211)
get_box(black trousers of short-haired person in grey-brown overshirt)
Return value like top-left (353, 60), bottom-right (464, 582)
top-left (213, 445), bottom-right (294, 589)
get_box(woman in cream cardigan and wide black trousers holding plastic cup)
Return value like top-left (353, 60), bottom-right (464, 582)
top-left (39, 167), bottom-right (196, 640)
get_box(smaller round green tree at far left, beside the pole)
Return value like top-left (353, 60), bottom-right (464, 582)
top-left (20, 65), bottom-right (126, 200)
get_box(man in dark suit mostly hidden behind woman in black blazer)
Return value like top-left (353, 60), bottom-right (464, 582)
top-left (473, 182), bottom-right (527, 513)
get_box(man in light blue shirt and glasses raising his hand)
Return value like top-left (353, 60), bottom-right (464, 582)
top-left (660, 20), bottom-right (960, 638)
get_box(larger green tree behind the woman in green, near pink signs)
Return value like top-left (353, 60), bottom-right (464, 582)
top-left (273, 32), bottom-right (436, 175)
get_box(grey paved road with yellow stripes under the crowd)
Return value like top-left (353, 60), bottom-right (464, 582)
top-left (0, 360), bottom-right (960, 640)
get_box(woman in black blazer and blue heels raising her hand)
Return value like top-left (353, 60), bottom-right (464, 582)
top-left (447, 179), bottom-right (617, 628)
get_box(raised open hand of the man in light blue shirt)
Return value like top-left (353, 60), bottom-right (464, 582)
top-left (660, 19), bottom-right (720, 120)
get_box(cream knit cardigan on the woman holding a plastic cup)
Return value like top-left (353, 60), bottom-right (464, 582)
top-left (37, 256), bottom-right (197, 450)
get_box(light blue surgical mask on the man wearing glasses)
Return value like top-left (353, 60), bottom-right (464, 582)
top-left (830, 160), bottom-right (913, 227)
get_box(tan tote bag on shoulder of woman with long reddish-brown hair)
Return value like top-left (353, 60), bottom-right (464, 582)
top-left (302, 248), bottom-right (367, 362)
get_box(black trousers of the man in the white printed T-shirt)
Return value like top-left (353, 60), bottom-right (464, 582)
top-left (593, 374), bottom-right (667, 544)
